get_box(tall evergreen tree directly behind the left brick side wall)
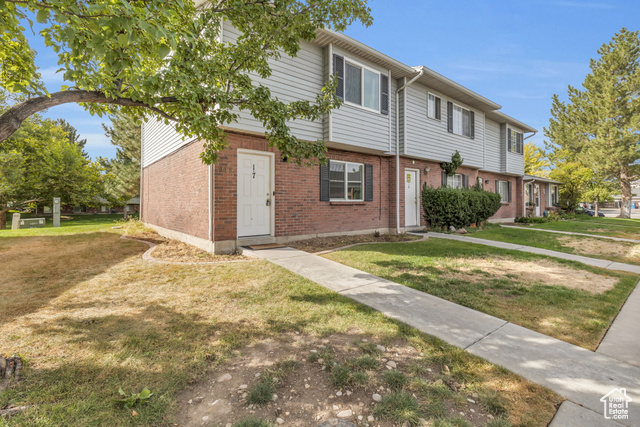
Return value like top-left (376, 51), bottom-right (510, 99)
top-left (102, 110), bottom-right (141, 211)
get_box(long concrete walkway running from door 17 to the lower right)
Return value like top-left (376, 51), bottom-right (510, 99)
top-left (245, 246), bottom-right (640, 427)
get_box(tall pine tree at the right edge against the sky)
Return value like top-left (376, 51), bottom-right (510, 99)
top-left (545, 28), bottom-right (640, 218)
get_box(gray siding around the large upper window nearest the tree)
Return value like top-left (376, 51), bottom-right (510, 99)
top-left (331, 48), bottom-right (396, 152)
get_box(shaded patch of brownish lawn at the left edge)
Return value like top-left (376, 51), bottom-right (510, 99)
top-left (0, 232), bottom-right (147, 323)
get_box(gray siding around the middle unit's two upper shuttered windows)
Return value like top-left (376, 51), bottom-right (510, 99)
top-left (404, 83), bottom-right (484, 168)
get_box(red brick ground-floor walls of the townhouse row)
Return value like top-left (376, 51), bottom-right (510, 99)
top-left (142, 133), bottom-right (522, 251)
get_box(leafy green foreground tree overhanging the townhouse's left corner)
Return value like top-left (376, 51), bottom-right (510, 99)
top-left (0, 0), bottom-right (371, 163)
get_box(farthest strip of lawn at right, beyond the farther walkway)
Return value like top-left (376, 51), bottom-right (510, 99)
top-left (517, 215), bottom-right (640, 240)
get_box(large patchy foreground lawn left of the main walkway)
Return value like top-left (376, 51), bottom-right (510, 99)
top-left (0, 226), bottom-right (562, 427)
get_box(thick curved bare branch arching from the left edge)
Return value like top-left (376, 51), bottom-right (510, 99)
top-left (0, 90), bottom-right (178, 144)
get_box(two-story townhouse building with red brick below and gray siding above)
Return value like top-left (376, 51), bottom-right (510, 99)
top-left (141, 25), bottom-right (536, 253)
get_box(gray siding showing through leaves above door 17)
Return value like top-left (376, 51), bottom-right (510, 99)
top-left (223, 23), bottom-right (325, 141)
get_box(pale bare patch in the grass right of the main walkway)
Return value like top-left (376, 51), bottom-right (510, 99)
top-left (444, 257), bottom-right (618, 294)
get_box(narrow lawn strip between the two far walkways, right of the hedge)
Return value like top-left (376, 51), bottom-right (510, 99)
top-left (473, 224), bottom-right (640, 265)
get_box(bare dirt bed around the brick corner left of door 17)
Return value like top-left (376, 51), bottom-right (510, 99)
top-left (127, 231), bottom-right (249, 263)
